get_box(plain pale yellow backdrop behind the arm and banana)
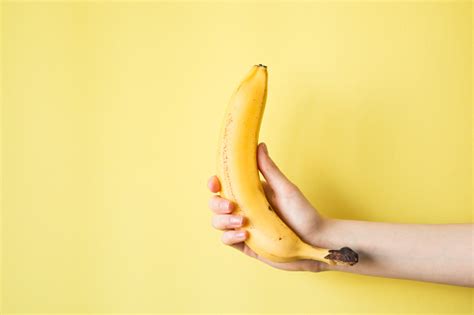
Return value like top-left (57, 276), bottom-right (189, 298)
top-left (1, 1), bottom-right (473, 313)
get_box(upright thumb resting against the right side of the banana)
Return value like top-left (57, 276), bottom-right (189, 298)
top-left (257, 143), bottom-right (295, 195)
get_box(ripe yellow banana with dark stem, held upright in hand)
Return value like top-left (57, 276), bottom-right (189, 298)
top-left (217, 64), bottom-right (358, 265)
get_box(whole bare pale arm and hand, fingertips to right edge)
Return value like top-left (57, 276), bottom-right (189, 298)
top-left (208, 144), bottom-right (474, 287)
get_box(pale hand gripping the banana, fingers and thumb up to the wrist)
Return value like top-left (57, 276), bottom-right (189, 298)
top-left (208, 143), bottom-right (322, 271)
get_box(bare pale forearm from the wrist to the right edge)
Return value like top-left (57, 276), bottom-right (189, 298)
top-left (314, 219), bottom-right (474, 286)
